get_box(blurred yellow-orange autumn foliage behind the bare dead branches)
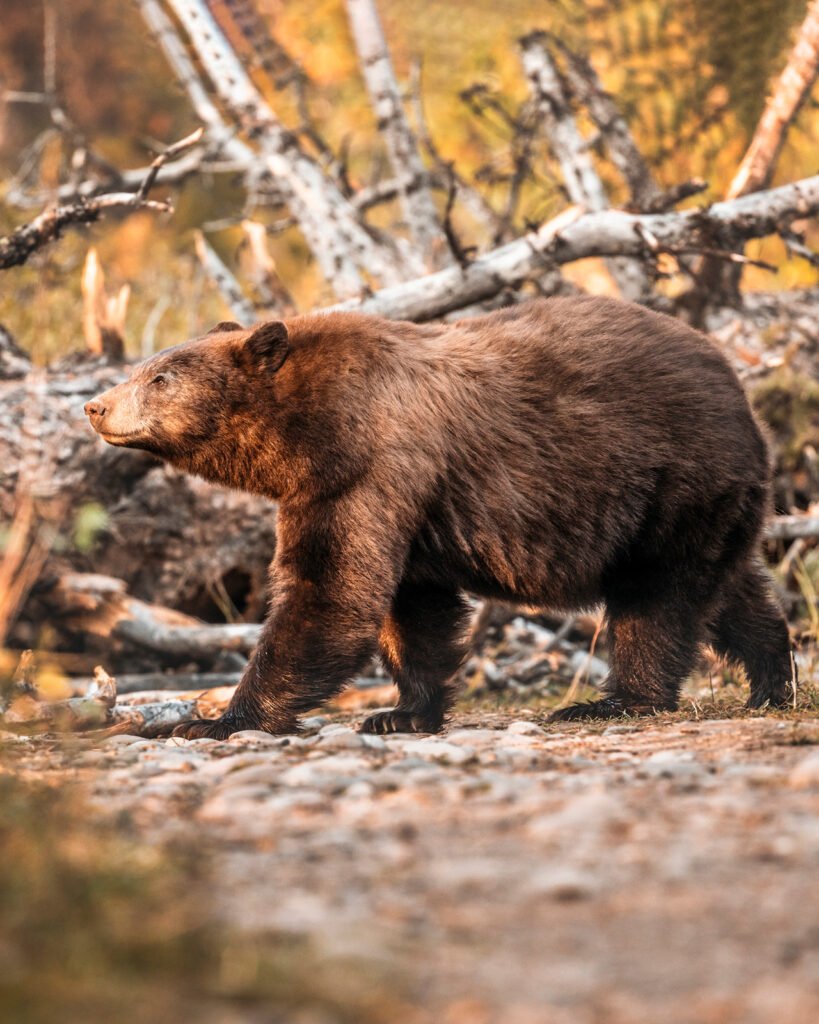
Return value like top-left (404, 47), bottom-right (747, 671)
top-left (0, 0), bottom-right (819, 358)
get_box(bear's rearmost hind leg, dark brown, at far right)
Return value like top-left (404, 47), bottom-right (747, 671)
top-left (710, 561), bottom-right (793, 708)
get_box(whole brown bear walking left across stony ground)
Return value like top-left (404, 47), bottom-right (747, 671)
top-left (85, 297), bottom-right (791, 737)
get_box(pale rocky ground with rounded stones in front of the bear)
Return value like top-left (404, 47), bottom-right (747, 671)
top-left (5, 707), bottom-right (819, 1024)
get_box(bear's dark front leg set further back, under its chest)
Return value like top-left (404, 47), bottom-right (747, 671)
top-left (361, 584), bottom-right (470, 733)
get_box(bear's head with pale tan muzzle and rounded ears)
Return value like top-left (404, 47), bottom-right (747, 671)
top-left (84, 321), bottom-right (290, 482)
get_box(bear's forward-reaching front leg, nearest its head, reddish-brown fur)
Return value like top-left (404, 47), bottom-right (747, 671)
top-left (174, 495), bottom-right (397, 739)
